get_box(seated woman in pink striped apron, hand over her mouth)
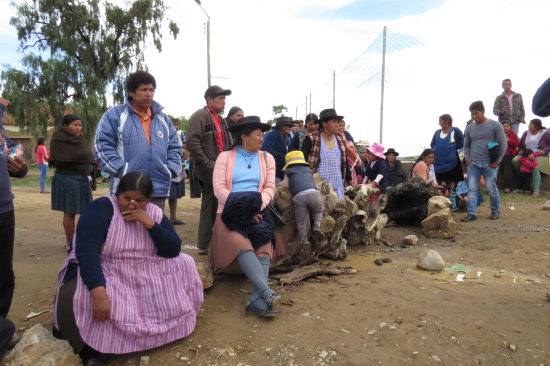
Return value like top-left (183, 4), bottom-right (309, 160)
top-left (53, 172), bottom-right (203, 365)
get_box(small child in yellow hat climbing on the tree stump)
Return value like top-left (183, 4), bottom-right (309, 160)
top-left (283, 151), bottom-right (325, 245)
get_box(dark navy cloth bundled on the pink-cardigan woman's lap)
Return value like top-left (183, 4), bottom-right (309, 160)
top-left (222, 191), bottom-right (275, 250)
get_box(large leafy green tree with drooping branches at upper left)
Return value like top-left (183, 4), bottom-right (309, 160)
top-left (1, 0), bottom-right (179, 134)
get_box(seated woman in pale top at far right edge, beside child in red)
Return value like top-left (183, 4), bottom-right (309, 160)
top-left (512, 118), bottom-right (550, 197)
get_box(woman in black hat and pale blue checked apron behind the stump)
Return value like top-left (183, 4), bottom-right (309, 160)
top-left (302, 109), bottom-right (353, 199)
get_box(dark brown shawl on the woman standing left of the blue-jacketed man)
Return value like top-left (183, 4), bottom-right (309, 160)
top-left (49, 126), bottom-right (96, 164)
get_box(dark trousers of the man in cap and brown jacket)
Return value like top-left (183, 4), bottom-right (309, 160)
top-left (194, 167), bottom-right (218, 249)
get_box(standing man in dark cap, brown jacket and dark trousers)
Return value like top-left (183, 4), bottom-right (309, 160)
top-left (187, 85), bottom-right (233, 255)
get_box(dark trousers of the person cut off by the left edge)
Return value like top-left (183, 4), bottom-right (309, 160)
top-left (0, 210), bottom-right (15, 318)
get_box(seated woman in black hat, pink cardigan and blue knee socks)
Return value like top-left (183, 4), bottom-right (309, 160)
top-left (210, 116), bottom-right (282, 317)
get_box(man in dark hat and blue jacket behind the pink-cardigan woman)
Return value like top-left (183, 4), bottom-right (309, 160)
top-left (262, 117), bottom-right (293, 184)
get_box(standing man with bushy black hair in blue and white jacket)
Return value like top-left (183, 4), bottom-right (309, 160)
top-left (94, 71), bottom-right (182, 209)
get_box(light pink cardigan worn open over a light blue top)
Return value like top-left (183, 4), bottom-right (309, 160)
top-left (212, 149), bottom-right (275, 213)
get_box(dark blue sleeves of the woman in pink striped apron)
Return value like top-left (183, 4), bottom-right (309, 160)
top-left (76, 197), bottom-right (181, 291)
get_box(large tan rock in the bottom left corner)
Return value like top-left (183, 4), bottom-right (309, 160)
top-left (3, 324), bottom-right (82, 366)
